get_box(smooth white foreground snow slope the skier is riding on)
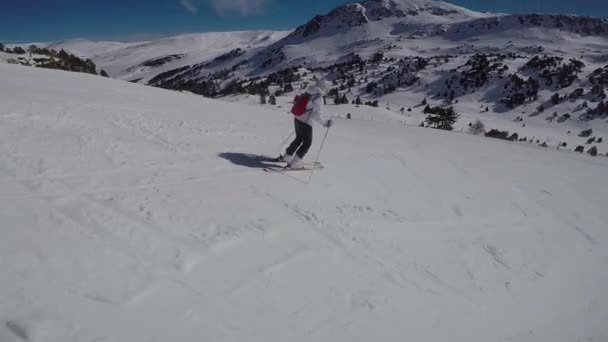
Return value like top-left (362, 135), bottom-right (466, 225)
top-left (0, 65), bottom-right (608, 342)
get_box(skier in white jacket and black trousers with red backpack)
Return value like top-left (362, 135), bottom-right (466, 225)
top-left (276, 79), bottom-right (333, 169)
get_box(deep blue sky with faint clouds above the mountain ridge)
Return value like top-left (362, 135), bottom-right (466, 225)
top-left (0, 0), bottom-right (608, 43)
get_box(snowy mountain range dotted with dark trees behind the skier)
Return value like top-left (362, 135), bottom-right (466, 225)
top-left (0, 0), bottom-right (608, 153)
